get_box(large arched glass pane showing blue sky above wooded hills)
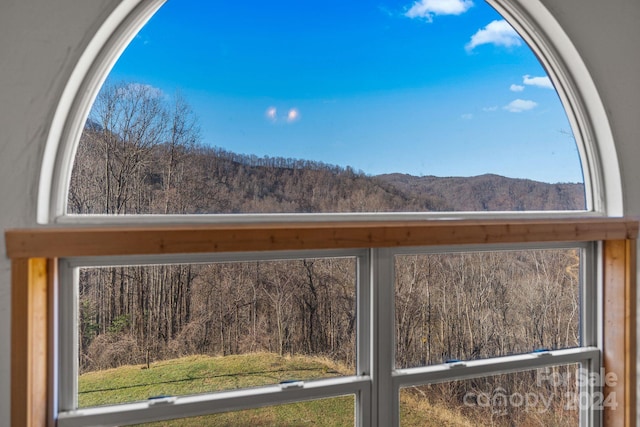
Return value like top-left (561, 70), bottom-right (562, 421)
top-left (67, 0), bottom-right (586, 214)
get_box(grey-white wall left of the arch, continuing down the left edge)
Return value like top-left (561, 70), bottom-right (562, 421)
top-left (0, 0), bottom-right (119, 427)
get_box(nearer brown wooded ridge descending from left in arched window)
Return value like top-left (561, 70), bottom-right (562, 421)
top-left (69, 131), bottom-right (445, 214)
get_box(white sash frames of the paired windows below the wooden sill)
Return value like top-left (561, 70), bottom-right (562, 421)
top-left (56, 243), bottom-right (602, 427)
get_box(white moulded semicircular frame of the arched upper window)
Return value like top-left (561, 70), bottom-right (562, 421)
top-left (37, 0), bottom-right (623, 224)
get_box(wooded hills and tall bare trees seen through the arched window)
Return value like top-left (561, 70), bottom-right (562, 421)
top-left (68, 85), bottom-right (585, 214)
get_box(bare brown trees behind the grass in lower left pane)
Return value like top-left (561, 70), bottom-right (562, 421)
top-left (79, 258), bottom-right (356, 372)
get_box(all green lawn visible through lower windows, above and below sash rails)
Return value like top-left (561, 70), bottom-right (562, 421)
top-left (78, 353), bottom-right (474, 427)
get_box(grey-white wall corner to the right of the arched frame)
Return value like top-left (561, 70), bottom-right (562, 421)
top-left (541, 0), bottom-right (640, 216)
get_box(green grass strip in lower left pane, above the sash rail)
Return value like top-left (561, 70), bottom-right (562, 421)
top-left (78, 353), bottom-right (353, 407)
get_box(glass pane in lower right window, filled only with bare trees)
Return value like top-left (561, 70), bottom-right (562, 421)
top-left (395, 249), bottom-right (581, 368)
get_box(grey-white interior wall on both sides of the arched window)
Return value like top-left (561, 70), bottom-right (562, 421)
top-left (0, 0), bottom-right (640, 427)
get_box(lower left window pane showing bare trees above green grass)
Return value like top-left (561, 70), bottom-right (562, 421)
top-left (78, 258), bottom-right (356, 407)
